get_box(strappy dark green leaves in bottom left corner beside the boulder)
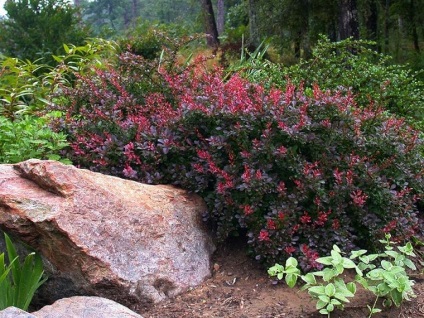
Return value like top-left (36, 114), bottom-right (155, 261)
top-left (0, 233), bottom-right (47, 310)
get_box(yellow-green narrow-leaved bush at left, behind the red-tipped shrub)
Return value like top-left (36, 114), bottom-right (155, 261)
top-left (0, 39), bottom-right (118, 120)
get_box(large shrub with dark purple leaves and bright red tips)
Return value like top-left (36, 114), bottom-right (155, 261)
top-left (51, 55), bottom-right (424, 269)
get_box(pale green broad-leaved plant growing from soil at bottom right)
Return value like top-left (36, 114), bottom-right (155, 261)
top-left (268, 234), bottom-right (416, 317)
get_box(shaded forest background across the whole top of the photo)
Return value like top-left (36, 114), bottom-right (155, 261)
top-left (0, 0), bottom-right (424, 70)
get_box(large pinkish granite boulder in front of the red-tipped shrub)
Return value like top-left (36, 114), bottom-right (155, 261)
top-left (0, 160), bottom-right (214, 309)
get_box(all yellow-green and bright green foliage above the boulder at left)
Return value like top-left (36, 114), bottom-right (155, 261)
top-left (0, 40), bottom-right (117, 163)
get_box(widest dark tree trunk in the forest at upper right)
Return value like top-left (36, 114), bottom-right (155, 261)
top-left (339, 0), bottom-right (359, 40)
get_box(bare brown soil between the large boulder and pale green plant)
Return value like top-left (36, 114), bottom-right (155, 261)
top-left (140, 240), bottom-right (424, 318)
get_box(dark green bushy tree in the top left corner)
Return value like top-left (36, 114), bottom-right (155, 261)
top-left (0, 0), bottom-right (90, 63)
